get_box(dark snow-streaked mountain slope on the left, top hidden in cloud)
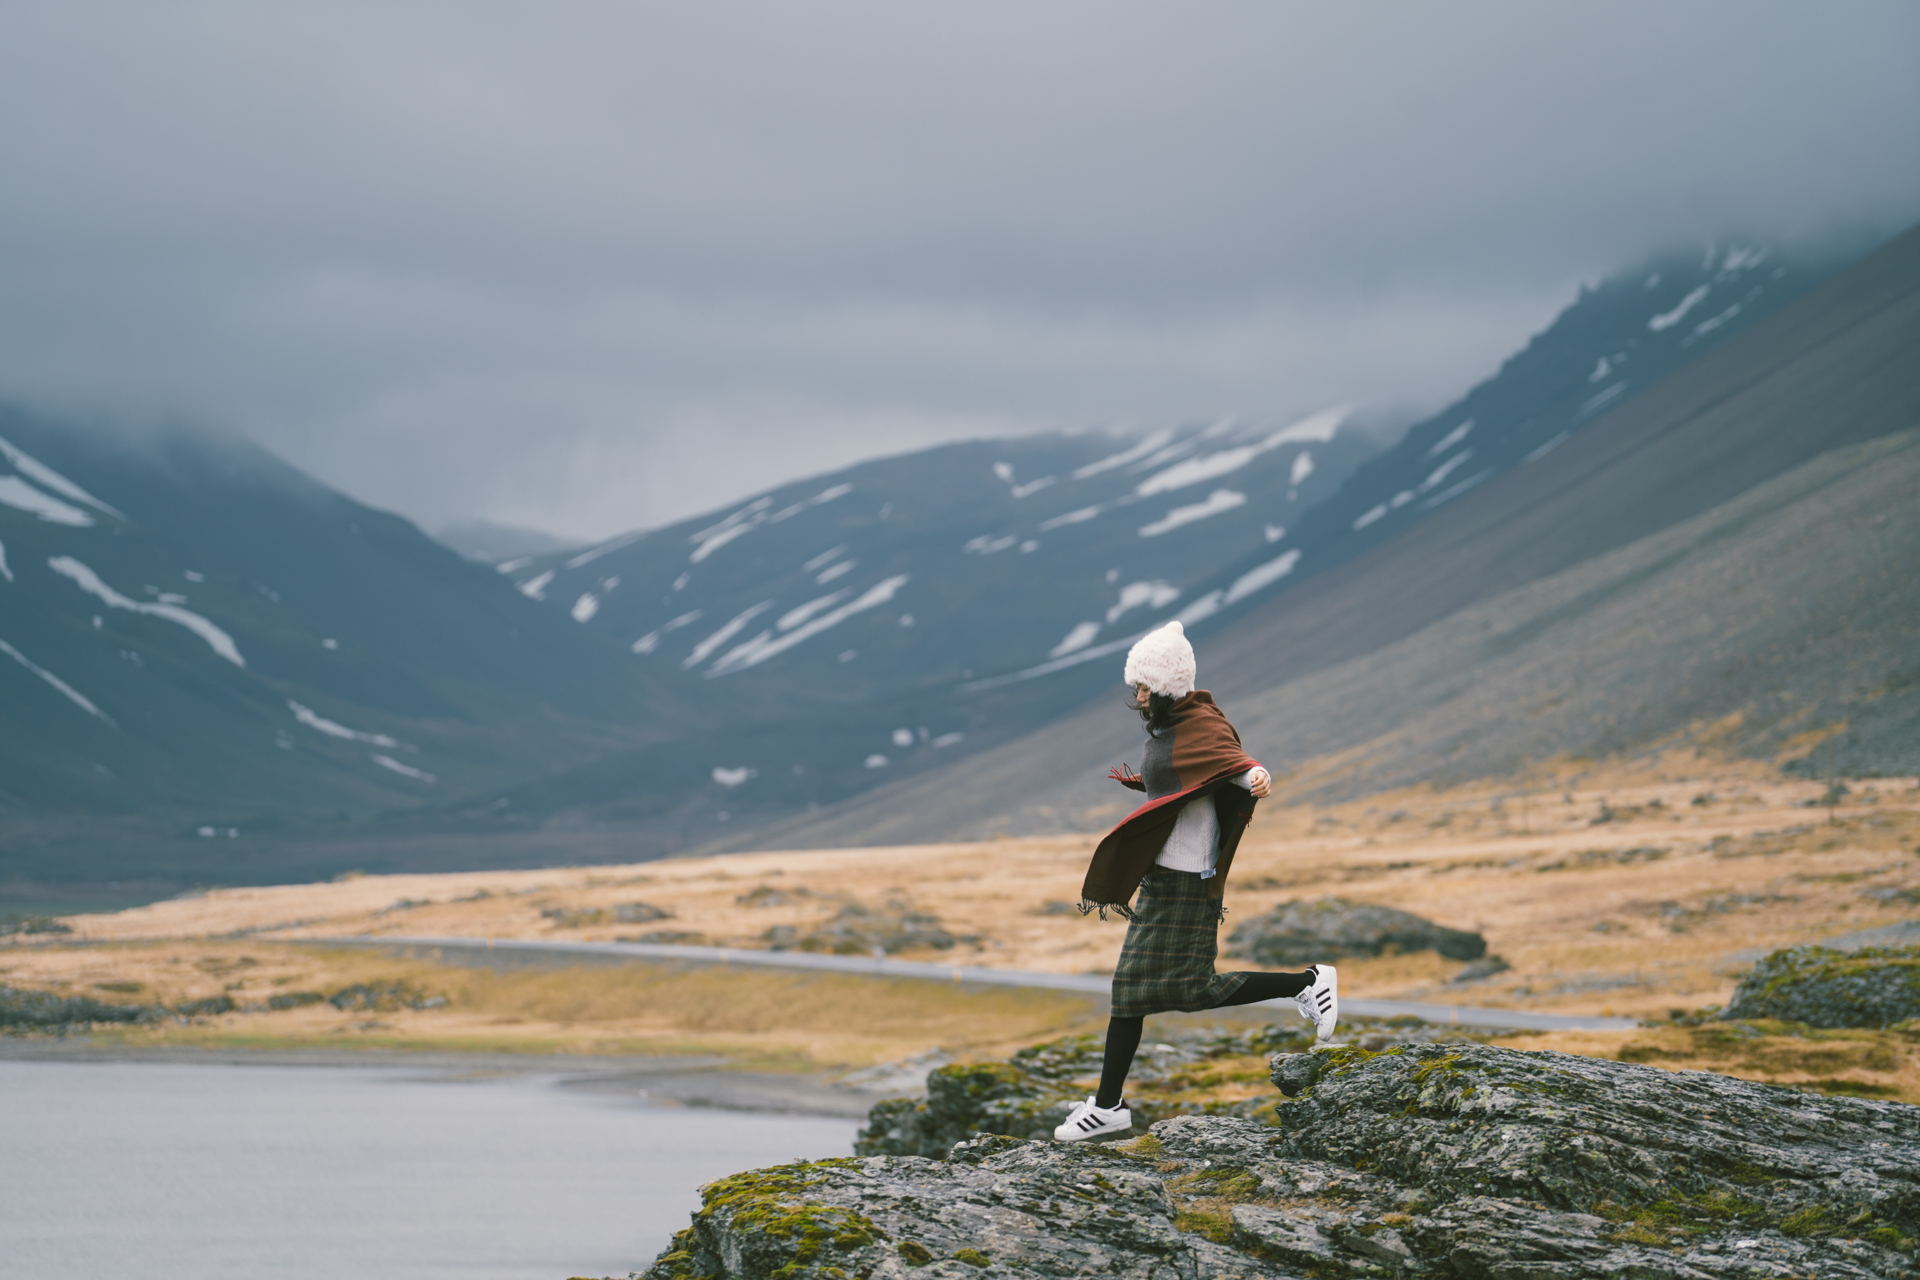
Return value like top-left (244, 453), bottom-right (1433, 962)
top-left (0, 420), bottom-right (662, 879)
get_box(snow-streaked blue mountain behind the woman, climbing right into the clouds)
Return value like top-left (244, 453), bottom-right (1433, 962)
top-left (435, 235), bottom-right (1841, 846)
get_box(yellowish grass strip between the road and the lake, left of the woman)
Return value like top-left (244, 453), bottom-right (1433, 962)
top-left (0, 942), bottom-right (1098, 1069)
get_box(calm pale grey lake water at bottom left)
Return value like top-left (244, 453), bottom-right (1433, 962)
top-left (0, 1061), bottom-right (856, 1280)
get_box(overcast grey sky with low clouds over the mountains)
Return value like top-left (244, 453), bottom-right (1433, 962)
top-left (0, 0), bottom-right (1920, 537)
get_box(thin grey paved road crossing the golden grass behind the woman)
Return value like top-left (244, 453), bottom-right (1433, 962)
top-left (311, 935), bottom-right (1640, 1031)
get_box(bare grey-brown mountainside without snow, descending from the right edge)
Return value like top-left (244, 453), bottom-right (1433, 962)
top-left (721, 222), bottom-right (1920, 844)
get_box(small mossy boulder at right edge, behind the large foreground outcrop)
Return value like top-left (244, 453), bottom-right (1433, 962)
top-left (1720, 946), bottom-right (1920, 1027)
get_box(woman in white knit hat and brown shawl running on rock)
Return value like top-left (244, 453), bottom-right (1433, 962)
top-left (1054, 622), bottom-right (1340, 1142)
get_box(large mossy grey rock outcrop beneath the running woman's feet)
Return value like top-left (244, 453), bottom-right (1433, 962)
top-left (647, 1044), bottom-right (1920, 1280)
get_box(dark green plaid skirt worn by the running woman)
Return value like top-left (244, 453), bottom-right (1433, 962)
top-left (1114, 867), bottom-right (1246, 1017)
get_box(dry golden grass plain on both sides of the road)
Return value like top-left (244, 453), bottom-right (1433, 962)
top-left (15, 750), bottom-right (1920, 1088)
